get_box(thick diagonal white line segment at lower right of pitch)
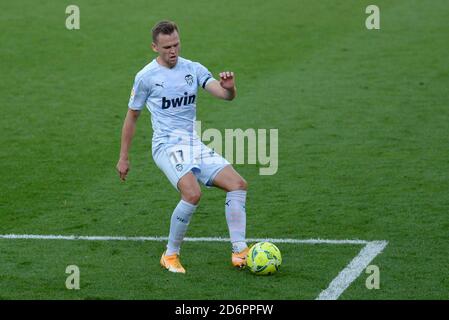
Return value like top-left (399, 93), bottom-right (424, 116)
top-left (315, 241), bottom-right (388, 300)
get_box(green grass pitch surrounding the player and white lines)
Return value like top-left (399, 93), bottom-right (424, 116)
top-left (0, 0), bottom-right (449, 300)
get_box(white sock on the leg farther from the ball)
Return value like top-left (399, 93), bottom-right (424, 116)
top-left (165, 199), bottom-right (197, 256)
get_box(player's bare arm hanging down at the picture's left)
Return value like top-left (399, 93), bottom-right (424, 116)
top-left (117, 109), bottom-right (140, 181)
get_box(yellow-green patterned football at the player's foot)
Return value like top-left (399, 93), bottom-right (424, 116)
top-left (247, 242), bottom-right (282, 275)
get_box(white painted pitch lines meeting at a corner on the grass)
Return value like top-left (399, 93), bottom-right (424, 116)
top-left (0, 234), bottom-right (388, 300)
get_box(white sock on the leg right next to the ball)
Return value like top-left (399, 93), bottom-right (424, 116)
top-left (225, 190), bottom-right (247, 252)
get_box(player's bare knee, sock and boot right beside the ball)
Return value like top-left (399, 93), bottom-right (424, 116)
top-left (212, 165), bottom-right (248, 268)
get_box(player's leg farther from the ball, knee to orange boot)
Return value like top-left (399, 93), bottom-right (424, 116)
top-left (161, 172), bottom-right (201, 273)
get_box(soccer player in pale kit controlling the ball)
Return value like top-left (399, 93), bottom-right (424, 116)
top-left (117, 21), bottom-right (248, 273)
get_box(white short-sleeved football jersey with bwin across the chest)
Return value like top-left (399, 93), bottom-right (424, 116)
top-left (128, 57), bottom-right (213, 151)
